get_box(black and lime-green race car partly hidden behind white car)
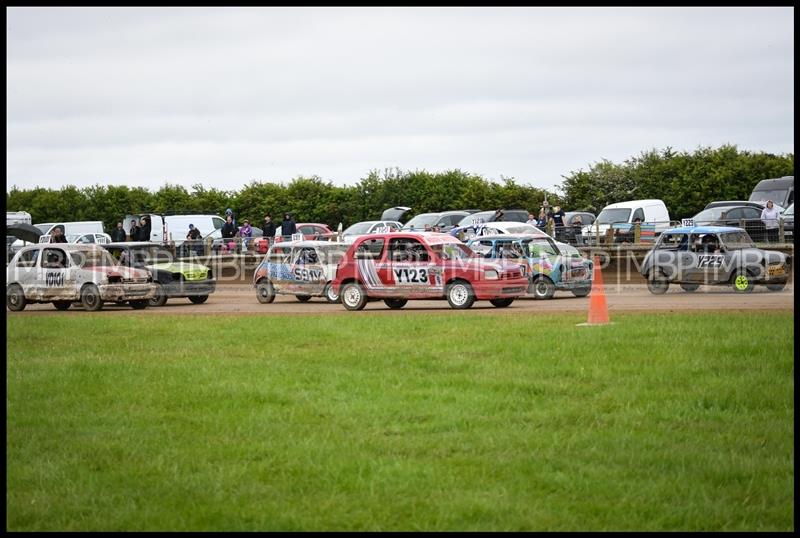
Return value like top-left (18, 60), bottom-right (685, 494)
top-left (102, 241), bottom-right (217, 306)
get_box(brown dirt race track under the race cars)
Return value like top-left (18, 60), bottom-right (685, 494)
top-left (7, 283), bottom-right (794, 316)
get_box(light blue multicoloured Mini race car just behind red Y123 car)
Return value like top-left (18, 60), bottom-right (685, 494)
top-left (467, 235), bottom-right (593, 299)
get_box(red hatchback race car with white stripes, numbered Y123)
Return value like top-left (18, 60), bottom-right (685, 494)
top-left (333, 232), bottom-right (528, 310)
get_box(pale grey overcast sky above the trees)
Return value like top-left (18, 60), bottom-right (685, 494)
top-left (6, 8), bottom-right (794, 190)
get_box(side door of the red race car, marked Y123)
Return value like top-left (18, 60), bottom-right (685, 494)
top-left (378, 237), bottom-right (441, 298)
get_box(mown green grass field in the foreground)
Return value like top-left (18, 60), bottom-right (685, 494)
top-left (6, 312), bottom-right (794, 531)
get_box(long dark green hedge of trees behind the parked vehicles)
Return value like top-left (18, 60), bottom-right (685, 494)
top-left (6, 145), bottom-right (794, 229)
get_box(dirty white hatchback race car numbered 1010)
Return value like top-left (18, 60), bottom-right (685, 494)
top-left (6, 243), bottom-right (155, 312)
